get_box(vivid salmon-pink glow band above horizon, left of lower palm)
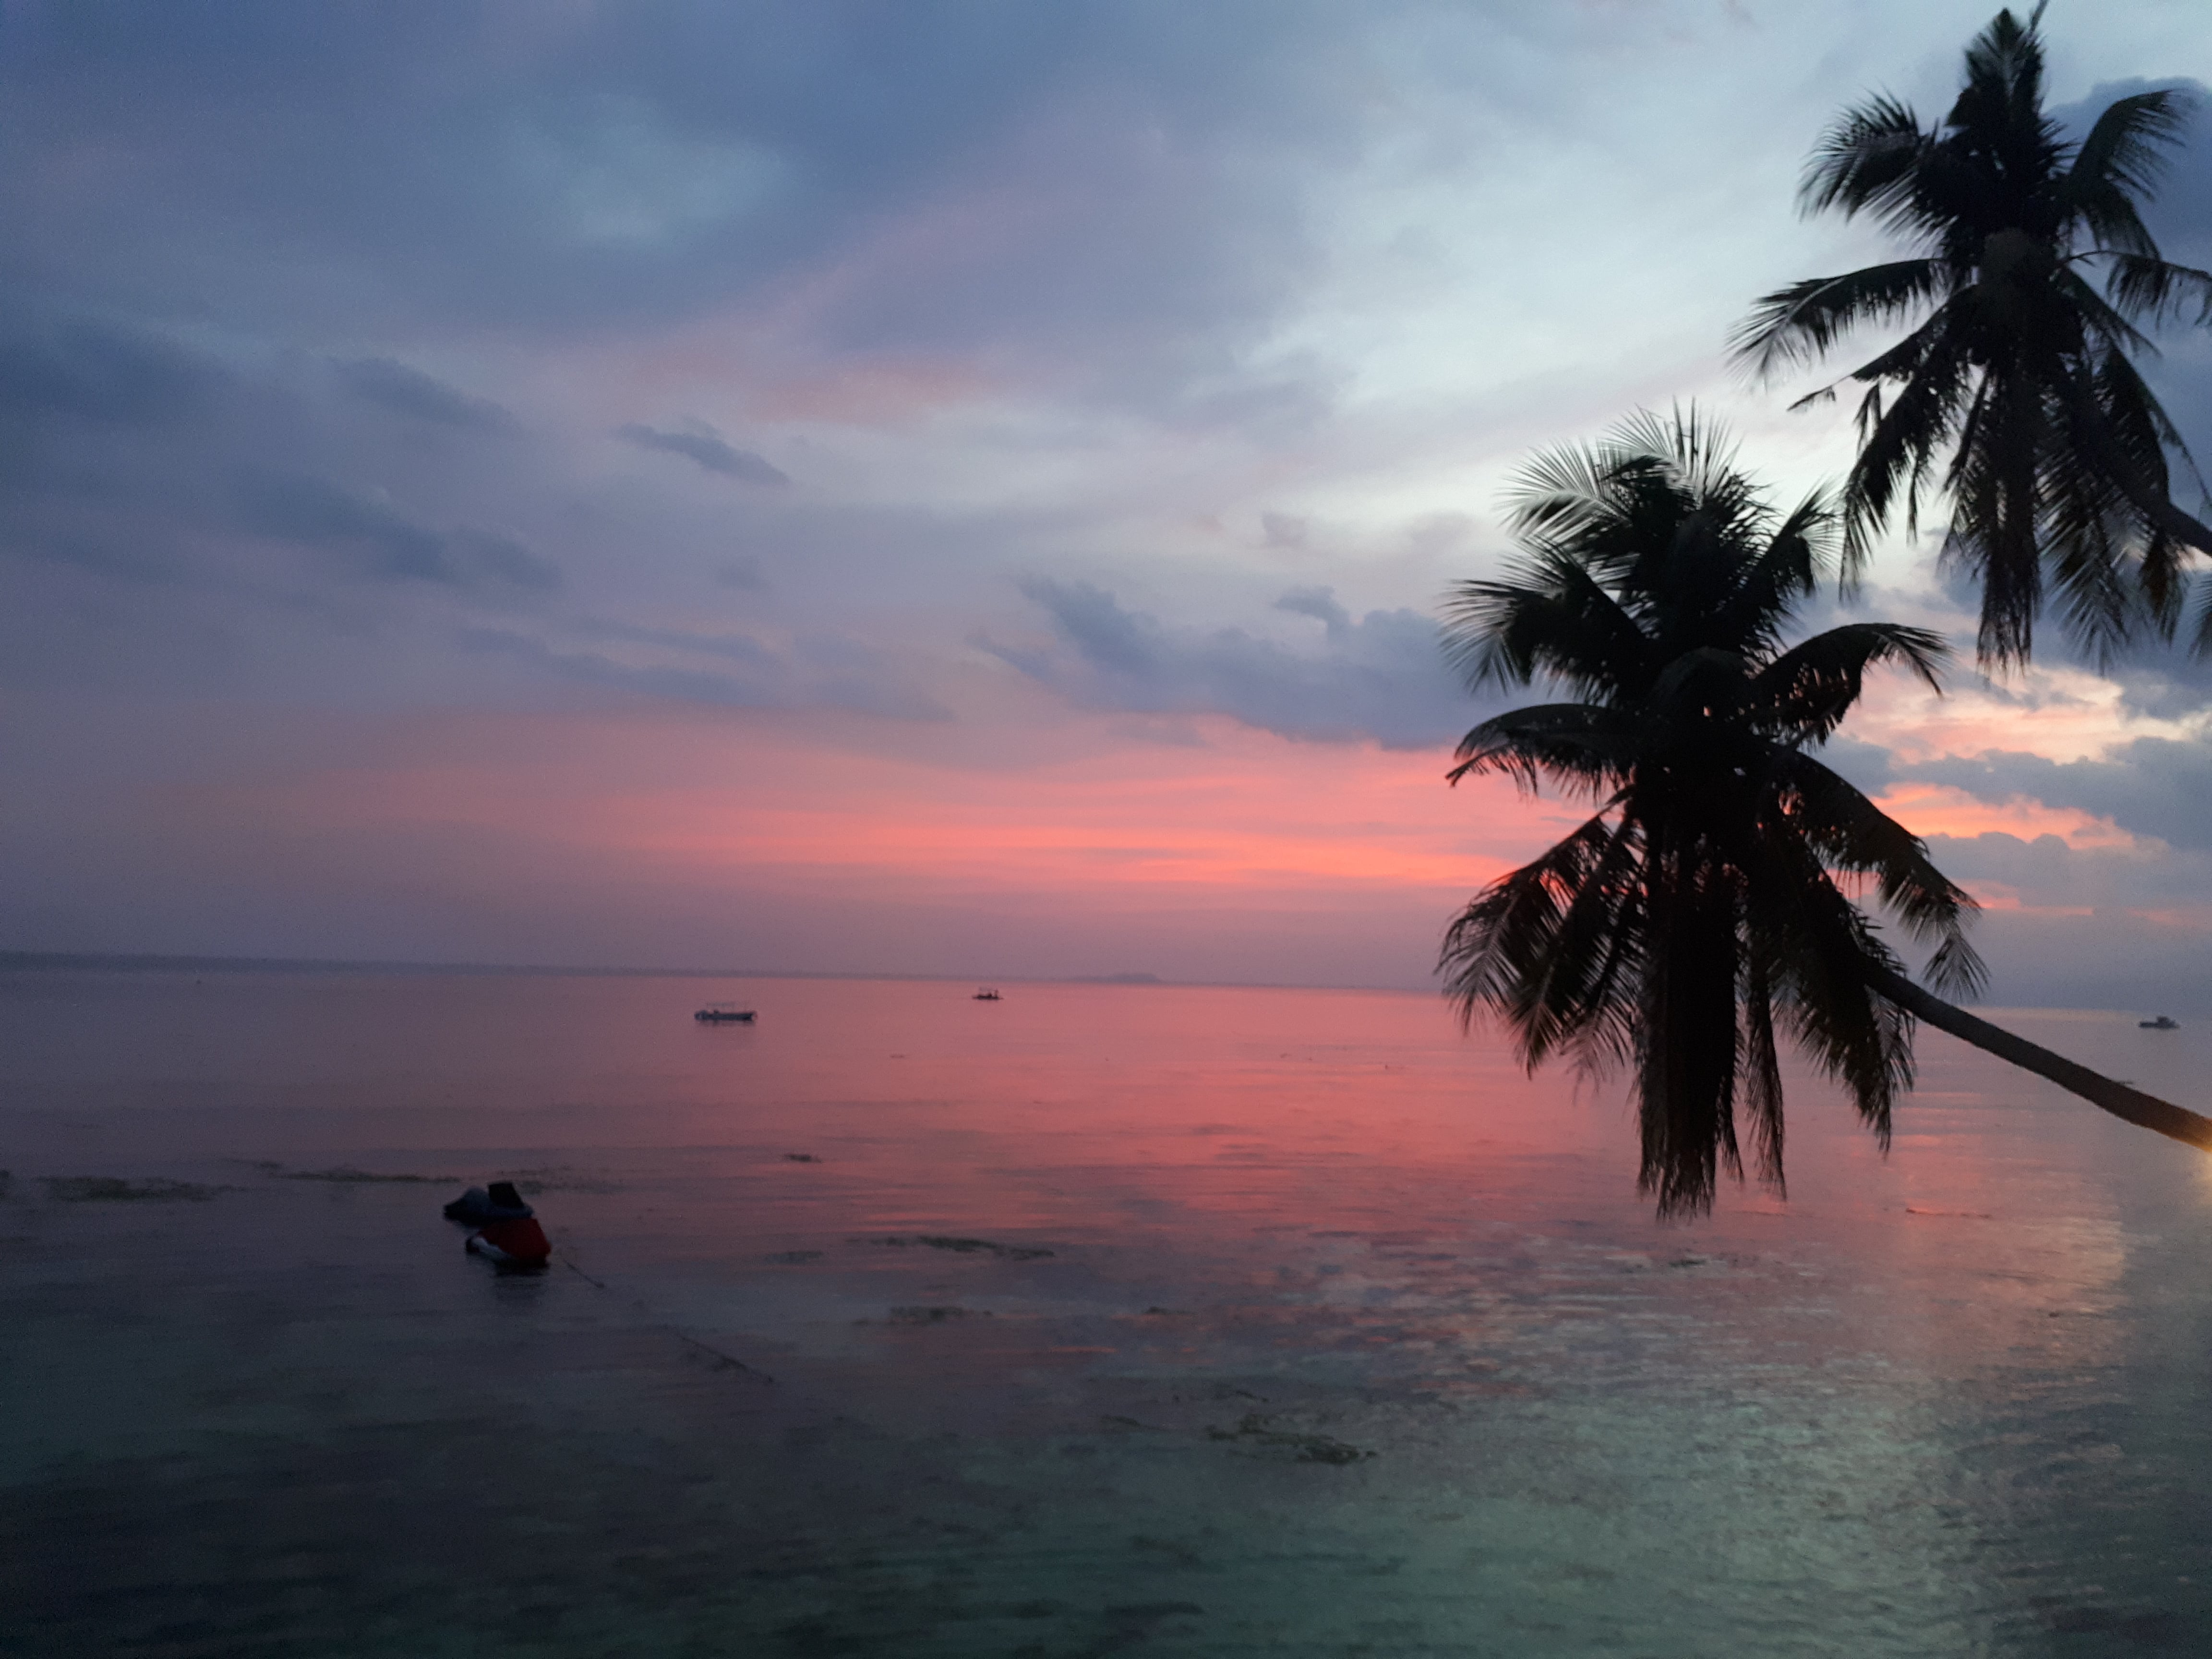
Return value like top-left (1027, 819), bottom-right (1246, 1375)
top-left (491, 719), bottom-right (1553, 907)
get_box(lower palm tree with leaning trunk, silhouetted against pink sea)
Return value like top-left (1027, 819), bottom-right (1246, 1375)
top-left (1440, 414), bottom-right (2212, 1214)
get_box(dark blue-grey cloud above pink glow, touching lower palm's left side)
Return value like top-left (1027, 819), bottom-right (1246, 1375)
top-left (978, 577), bottom-right (1484, 748)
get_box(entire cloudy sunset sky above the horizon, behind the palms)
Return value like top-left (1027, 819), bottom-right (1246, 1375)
top-left (0, 0), bottom-right (2212, 1013)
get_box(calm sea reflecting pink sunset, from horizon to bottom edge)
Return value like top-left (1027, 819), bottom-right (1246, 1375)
top-left (0, 974), bottom-right (2212, 1659)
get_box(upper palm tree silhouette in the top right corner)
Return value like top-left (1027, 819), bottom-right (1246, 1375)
top-left (1734, 4), bottom-right (2212, 668)
